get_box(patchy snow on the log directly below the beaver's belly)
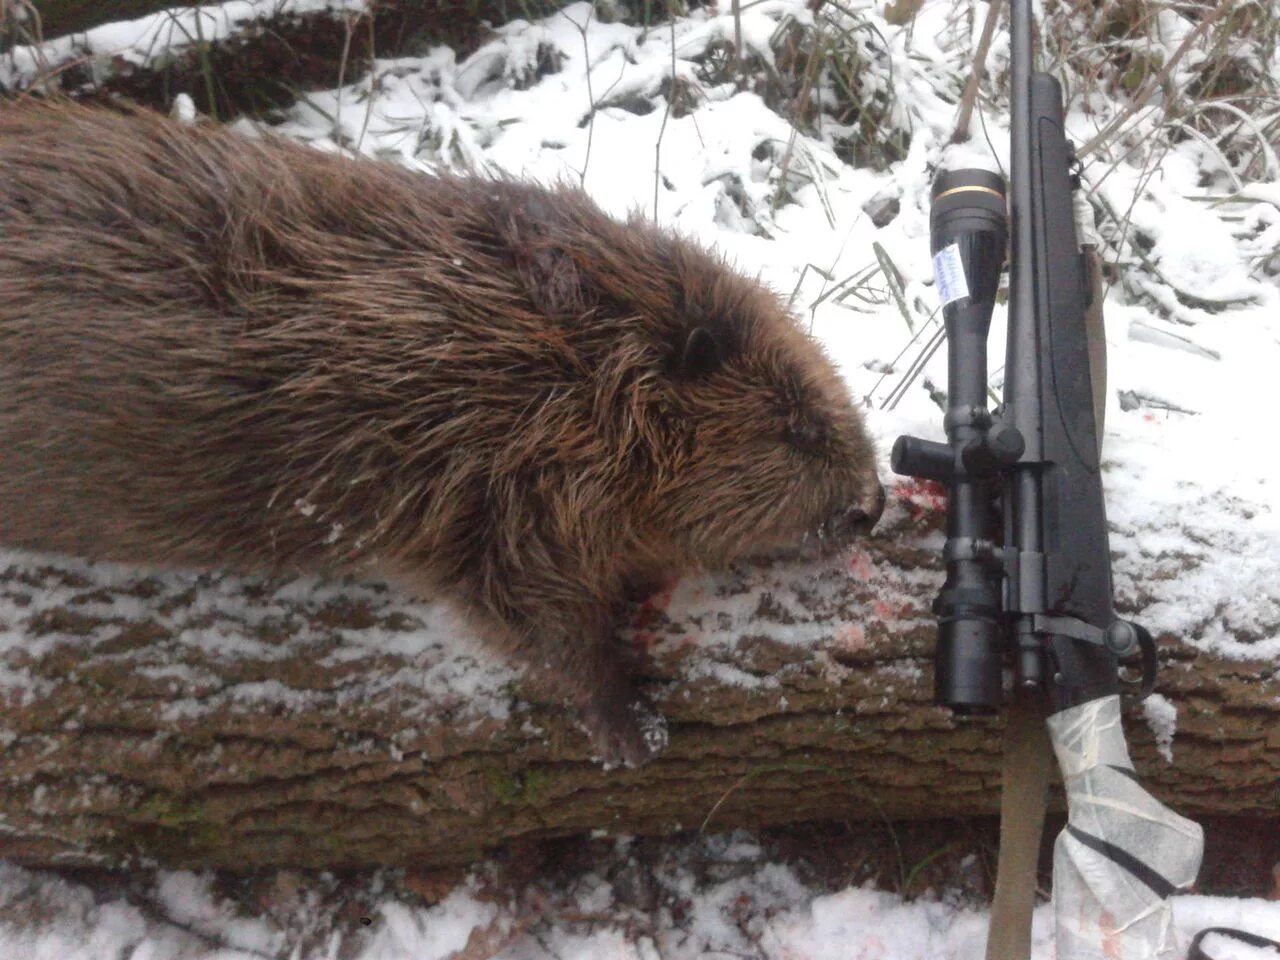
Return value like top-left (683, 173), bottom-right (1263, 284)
top-left (0, 549), bottom-right (517, 722)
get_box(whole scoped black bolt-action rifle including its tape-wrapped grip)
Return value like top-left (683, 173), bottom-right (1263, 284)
top-left (892, 0), bottom-right (1203, 960)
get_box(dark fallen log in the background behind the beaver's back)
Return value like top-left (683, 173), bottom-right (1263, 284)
top-left (0, 0), bottom-right (558, 120)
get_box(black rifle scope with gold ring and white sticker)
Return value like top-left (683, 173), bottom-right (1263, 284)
top-left (892, 170), bottom-right (1024, 713)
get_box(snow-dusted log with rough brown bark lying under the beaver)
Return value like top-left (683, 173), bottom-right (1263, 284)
top-left (0, 484), bottom-right (1280, 869)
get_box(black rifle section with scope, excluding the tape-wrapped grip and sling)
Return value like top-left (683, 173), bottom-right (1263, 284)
top-left (892, 4), bottom-right (1155, 713)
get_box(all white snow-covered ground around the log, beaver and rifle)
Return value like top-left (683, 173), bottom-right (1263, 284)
top-left (0, 0), bottom-right (1280, 960)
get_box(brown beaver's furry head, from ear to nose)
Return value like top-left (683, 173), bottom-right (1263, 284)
top-left (634, 244), bottom-right (884, 564)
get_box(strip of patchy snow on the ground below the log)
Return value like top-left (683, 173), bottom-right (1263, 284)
top-left (0, 835), bottom-right (1280, 960)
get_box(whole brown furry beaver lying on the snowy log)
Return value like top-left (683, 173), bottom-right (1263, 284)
top-left (0, 104), bottom-right (883, 764)
